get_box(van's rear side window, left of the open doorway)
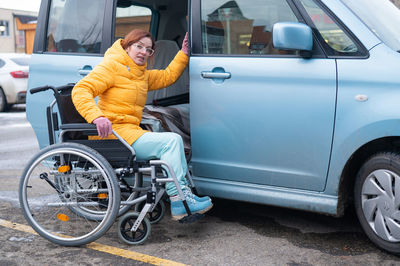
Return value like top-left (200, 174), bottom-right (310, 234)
top-left (46, 0), bottom-right (105, 53)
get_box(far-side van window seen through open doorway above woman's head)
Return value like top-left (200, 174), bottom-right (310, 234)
top-left (114, 0), bottom-right (152, 40)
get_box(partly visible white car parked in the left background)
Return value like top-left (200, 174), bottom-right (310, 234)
top-left (0, 53), bottom-right (30, 112)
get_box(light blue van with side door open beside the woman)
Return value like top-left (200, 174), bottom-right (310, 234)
top-left (27, 0), bottom-right (400, 253)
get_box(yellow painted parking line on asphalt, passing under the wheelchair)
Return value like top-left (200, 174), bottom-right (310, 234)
top-left (0, 219), bottom-right (185, 266)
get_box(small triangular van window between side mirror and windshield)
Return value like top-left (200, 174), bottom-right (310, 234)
top-left (301, 0), bottom-right (358, 54)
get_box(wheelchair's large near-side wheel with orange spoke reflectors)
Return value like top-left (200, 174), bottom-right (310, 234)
top-left (19, 143), bottom-right (120, 246)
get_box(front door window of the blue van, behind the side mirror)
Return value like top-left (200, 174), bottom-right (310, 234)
top-left (201, 0), bottom-right (298, 55)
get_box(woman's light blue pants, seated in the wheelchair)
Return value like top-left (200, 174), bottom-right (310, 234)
top-left (132, 132), bottom-right (187, 196)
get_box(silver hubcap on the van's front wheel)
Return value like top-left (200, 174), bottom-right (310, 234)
top-left (361, 169), bottom-right (400, 242)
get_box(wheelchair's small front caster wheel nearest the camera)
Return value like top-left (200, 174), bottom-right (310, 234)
top-left (118, 212), bottom-right (151, 245)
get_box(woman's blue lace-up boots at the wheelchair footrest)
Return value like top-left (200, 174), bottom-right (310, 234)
top-left (170, 193), bottom-right (213, 221)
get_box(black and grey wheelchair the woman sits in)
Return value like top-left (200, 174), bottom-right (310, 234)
top-left (19, 84), bottom-right (203, 246)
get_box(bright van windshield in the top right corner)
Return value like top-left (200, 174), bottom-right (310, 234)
top-left (342, 0), bottom-right (400, 52)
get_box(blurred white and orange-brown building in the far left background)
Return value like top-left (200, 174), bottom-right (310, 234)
top-left (0, 8), bottom-right (38, 54)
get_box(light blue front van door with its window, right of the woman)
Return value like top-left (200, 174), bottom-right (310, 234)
top-left (190, 0), bottom-right (336, 192)
